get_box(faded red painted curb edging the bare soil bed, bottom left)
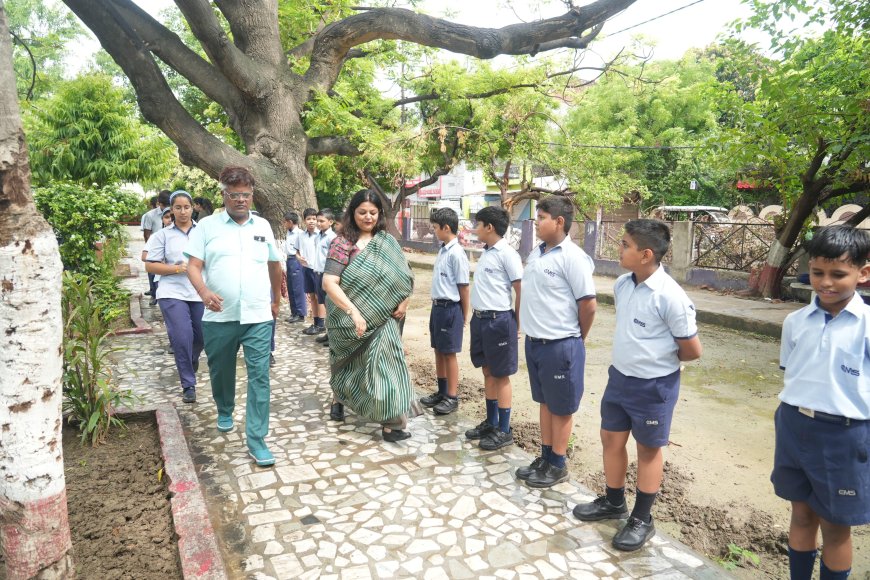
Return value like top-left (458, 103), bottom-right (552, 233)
top-left (155, 403), bottom-right (227, 580)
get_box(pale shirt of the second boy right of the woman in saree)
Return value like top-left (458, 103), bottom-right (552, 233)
top-left (471, 238), bottom-right (523, 311)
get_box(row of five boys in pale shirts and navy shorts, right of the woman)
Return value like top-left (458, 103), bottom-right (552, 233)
top-left (421, 202), bottom-right (870, 580)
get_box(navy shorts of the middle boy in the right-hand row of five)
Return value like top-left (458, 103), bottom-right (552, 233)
top-left (526, 336), bottom-right (586, 416)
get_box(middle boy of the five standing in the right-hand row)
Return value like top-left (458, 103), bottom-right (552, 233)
top-left (516, 195), bottom-right (598, 488)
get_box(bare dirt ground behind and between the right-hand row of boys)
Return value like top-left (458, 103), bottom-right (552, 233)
top-left (404, 269), bottom-right (870, 579)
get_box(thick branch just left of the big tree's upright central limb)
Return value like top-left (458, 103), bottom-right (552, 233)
top-left (174, 0), bottom-right (260, 96)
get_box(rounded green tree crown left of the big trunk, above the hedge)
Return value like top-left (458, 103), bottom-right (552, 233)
top-left (24, 75), bottom-right (174, 186)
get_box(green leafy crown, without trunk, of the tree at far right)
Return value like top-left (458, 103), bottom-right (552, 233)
top-left (718, 24), bottom-right (870, 212)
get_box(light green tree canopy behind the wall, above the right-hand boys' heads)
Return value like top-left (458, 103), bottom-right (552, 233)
top-left (555, 51), bottom-right (734, 207)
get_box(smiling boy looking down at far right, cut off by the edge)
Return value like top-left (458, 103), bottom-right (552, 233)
top-left (770, 226), bottom-right (870, 580)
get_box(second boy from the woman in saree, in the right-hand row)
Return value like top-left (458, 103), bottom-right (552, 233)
top-left (465, 206), bottom-right (523, 451)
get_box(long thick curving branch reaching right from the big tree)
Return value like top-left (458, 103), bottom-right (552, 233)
top-left (305, 0), bottom-right (635, 90)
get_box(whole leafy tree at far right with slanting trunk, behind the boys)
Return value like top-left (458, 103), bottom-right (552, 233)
top-left (724, 0), bottom-right (870, 297)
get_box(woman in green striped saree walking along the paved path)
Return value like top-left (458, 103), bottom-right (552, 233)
top-left (323, 189), bottom-right (414, 442)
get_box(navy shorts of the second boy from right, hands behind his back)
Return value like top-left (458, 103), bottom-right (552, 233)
top-left (601, 366), bottom-right (680, 447)
